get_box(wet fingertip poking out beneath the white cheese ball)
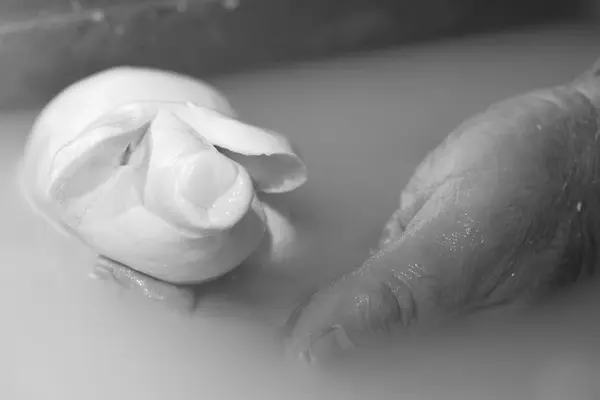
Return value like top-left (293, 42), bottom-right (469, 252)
top-left (92, 256), bottom-right (196, 314)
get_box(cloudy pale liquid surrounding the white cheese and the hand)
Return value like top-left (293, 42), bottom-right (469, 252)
top-left (0, 24), bottom-right (600, 400)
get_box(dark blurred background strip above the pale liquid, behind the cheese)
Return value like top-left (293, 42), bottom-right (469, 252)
top-left (0, 0), bottom-right (595, 109)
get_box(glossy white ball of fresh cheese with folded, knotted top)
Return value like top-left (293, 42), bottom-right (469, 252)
top-left (21, 68), bottom-right (306, 283)
